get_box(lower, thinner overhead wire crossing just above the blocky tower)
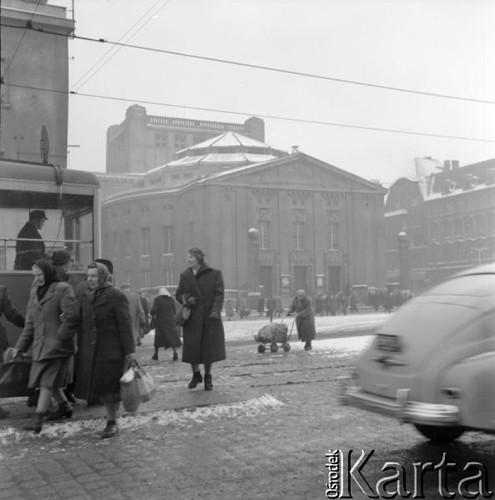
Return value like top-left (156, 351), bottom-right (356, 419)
top-left (9, 83), bottom-right (495, 143)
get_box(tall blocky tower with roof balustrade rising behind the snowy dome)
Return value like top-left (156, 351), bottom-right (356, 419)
top-left (106, 104), bottom-right (265, 174)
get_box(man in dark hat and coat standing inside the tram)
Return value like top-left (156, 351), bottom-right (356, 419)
top-left (14, 210), bottom-right (48, 271)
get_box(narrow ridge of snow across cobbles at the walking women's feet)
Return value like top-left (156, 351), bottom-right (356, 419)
top-left (0, 394), bottom-right (284, 442)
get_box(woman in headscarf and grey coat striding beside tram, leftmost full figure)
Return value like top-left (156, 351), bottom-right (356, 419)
top-left (16, 260), bottom-right (79, 433)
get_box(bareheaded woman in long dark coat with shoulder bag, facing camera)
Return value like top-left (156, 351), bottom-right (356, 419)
top-left (175, 247), bottom-right (227, 391)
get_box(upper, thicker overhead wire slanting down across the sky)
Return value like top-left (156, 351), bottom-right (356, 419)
top-left (0, 24), bottom-right (495, 104)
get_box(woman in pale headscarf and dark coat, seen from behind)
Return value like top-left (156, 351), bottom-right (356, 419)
top-left (151, 287), bottom-right (182, 361)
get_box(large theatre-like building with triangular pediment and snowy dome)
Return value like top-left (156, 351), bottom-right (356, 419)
top-left (102, 133), bottom-right (385, 297)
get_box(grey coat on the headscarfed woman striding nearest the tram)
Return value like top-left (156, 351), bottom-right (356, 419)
top-left (16, 282), bottom-right (79, 361)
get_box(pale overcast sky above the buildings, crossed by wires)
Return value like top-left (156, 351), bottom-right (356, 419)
top-left (58, 0), bottom-right (495, 183)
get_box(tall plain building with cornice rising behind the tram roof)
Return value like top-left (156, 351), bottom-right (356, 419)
top-left (0, 0), bottom-right (74, 168)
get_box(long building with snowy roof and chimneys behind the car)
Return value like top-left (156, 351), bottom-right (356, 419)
top-left (385, 159), bottom-right (495, 291)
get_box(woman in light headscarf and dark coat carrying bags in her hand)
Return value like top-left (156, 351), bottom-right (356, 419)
top-left (74, 262), bottom-right (135, 438)
